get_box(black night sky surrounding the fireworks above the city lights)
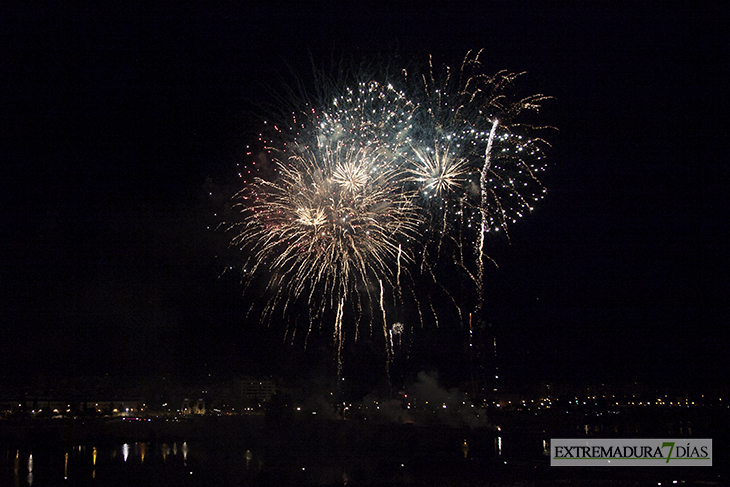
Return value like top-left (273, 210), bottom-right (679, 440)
top-left (0, 2), bottom-right (730, 388)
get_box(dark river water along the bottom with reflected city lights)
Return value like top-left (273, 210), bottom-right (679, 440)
top-left (0, 415), bottom-right (730, 487)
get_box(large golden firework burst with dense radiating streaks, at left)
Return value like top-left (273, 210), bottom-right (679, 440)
top-left (232, 136), bottom-right (419, 374)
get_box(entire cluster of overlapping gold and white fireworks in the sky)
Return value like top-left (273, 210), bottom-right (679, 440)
top-left (228, 52), bottom-right (546, 372)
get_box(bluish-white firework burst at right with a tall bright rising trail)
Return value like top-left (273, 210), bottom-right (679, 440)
top-left (406, 51), bottom-right (548, 308)
